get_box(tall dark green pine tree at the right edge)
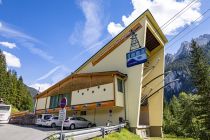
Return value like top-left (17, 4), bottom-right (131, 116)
top-left (190, 40), bottom-right (210, 136)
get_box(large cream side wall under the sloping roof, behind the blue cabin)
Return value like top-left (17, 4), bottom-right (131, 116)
top-left (78, 18), bottom-right (146, 127)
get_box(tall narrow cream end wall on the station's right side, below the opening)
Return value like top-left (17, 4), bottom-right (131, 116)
top-left (142, 18), bottom-right (164, 136)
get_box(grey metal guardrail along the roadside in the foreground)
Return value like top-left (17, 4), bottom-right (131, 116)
top-left (44, 123), bottom-right (126, 140)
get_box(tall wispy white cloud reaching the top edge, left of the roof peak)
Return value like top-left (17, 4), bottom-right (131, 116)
top-left (70, 0), bottom-right (103, 49)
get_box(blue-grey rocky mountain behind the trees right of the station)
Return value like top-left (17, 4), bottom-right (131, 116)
top-left (164, 34), bottom-right (210, 100)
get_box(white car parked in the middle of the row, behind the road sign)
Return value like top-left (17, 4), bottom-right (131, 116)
top-left (42, 116), bottom-right (61, 128)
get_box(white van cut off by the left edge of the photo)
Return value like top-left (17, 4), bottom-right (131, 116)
top-left (0, 103), bottom-right (12, 123)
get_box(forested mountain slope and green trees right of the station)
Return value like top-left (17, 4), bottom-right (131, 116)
top-left (163, 40), bottom-right (210, 140)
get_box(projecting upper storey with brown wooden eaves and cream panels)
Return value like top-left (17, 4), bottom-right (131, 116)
top-left (36, 71), bottom-right (127, 112)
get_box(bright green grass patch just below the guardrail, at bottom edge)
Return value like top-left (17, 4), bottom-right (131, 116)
top-left (93, 129), bottom-right (142, 140)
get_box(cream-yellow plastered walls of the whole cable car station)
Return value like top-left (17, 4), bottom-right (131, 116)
top-left (34, 12), bottom-right (164, 138)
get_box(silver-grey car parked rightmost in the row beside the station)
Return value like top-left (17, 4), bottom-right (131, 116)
top-left (63, 117), bottom-right (92, 130)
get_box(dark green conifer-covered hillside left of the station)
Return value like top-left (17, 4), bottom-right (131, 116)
top-left (0, 50), bottom-right (33, 111)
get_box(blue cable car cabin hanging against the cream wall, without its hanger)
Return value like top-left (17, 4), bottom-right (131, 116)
top-left (126, 47), bottom-right (147, 67)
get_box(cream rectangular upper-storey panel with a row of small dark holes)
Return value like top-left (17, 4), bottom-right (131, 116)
top-left (71, 83), bottom-right (114, 105)
